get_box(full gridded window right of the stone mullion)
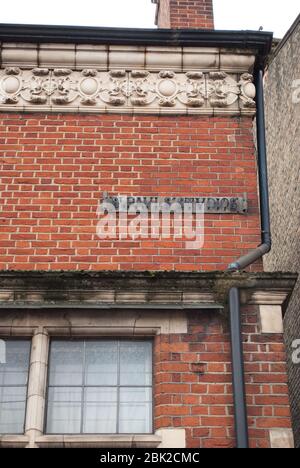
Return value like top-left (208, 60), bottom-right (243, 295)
top-left (47, 340), bottom-right (152, 434)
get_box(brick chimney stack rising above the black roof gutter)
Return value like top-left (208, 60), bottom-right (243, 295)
top-left (152, 0), bottom-right (214, 29)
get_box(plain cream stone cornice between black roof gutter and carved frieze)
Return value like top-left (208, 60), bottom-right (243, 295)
top-left (0, 42), bottom-right (256, 73)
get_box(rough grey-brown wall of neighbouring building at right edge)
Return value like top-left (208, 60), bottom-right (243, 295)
top-left (265, 17), bottom-right (300, 446)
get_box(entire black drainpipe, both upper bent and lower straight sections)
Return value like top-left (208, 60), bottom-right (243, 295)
top-left (228, 68), bottom-right (272, 449)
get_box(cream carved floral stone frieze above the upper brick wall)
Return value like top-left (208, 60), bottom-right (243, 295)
top-left (0, 67), bottom-right (256, 113)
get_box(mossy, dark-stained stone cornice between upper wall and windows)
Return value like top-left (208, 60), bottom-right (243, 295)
top-left (0, 272), bottom-right (297, 310)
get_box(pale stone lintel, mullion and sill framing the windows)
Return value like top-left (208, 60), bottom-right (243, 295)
top-left (0, 325), bottom-right (163, 448)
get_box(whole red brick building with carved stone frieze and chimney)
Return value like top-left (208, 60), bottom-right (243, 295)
top-left (0, 0), bottom-right (296, 448)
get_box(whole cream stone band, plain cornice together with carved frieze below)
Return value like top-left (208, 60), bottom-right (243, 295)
top-left (0, 44), bottom-right (256, 115)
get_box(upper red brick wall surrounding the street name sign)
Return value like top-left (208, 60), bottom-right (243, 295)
top-left (0, 114), bottom-right (261, 271)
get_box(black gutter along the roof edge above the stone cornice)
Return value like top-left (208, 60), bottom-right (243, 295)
top-left (0, 24), bottom-right (273, 57)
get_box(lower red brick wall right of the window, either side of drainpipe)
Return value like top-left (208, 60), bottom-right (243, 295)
top-left (155, 306), bottom-right (291, 448)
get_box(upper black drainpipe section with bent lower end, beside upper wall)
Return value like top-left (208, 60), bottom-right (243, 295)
top-left (228, 69), bottom-right (272, 271)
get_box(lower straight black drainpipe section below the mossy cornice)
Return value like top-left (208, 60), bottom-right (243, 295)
top-left (229, 288), bottom-right (249, 449)
